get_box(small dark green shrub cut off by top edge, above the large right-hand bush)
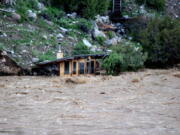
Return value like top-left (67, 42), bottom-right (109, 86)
top-left (136, 0), bottom-right (166, 11)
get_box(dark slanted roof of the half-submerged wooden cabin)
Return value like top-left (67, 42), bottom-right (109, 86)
top-left (36, 54), bottom-right (108, 66)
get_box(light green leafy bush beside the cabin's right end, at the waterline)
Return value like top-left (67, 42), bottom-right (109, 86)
top-left (103, 41), bottom-right (147, 75)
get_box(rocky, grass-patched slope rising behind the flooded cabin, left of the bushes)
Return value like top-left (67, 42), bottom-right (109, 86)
top-left (0, 3), bottom-right (124, 68)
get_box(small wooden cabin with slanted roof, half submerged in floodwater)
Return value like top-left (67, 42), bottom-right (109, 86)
top-left (37, 54), bottom-right (107, 76)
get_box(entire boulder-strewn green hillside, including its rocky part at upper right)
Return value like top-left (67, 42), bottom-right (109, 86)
top-left (0, 0), bottom-right (180, 74)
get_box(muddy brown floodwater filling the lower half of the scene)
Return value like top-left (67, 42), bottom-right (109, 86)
top-left (0, 69), bottom-right (180, 135)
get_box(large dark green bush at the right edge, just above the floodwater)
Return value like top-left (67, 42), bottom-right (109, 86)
top-left (139, 17), bottom-right (180, 67)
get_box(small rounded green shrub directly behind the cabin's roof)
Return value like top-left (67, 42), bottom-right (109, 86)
top-left (72, 42), bottom-right (91, 55)
